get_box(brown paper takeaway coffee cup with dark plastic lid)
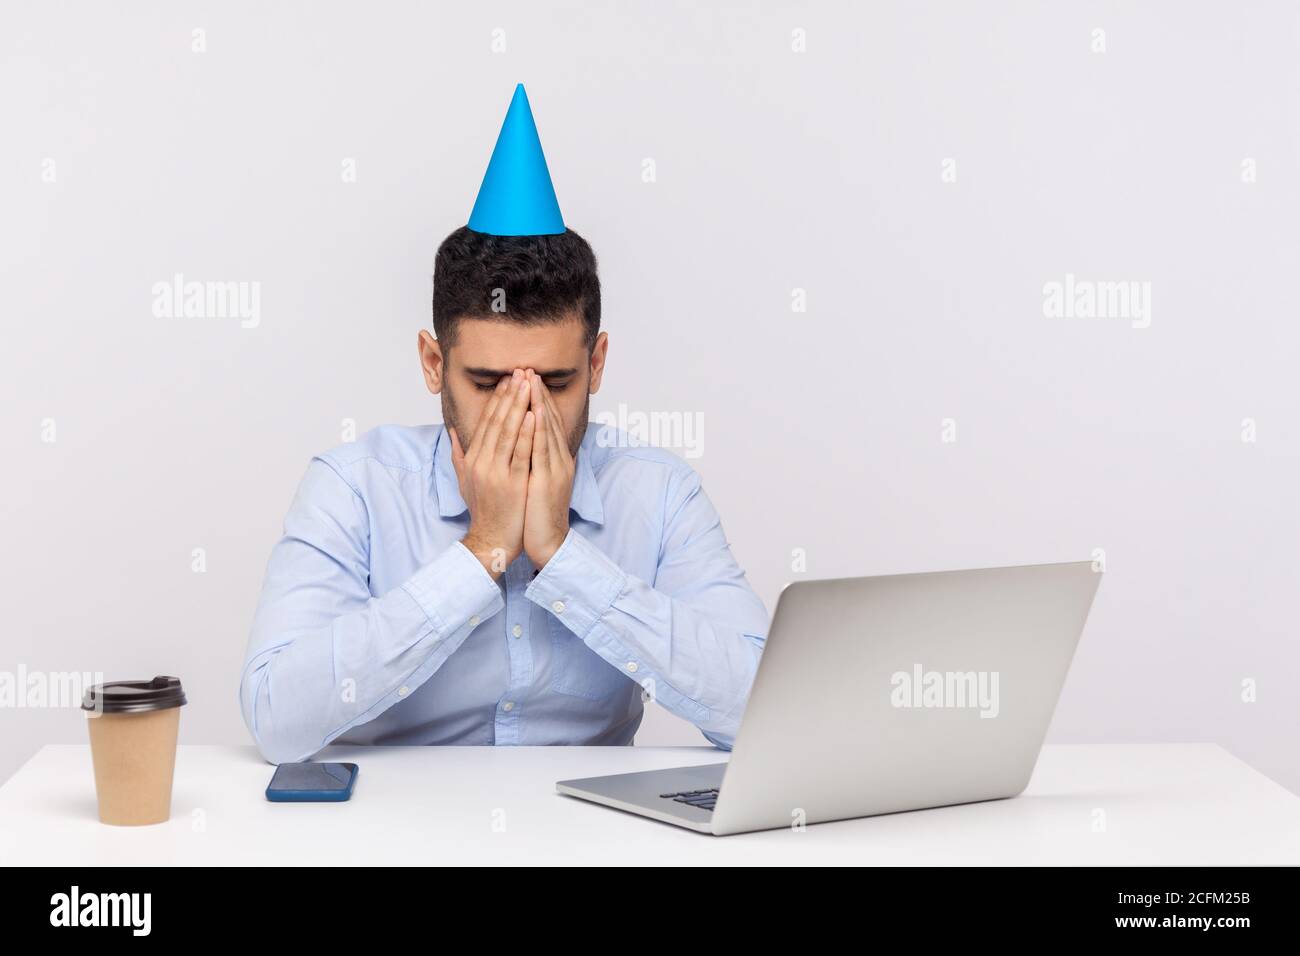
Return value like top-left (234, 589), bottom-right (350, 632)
top-left (82, 678), bottom-right (185, 826)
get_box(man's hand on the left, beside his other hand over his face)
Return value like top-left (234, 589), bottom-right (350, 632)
top-left (447, 369), bottom-right (536, 578)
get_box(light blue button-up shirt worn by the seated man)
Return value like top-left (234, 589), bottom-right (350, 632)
top-left (239, 423), bottom-right (768, 763)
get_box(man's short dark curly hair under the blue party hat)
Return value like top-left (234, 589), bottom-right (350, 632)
top-left (433, 226), bottom-right (601, 351)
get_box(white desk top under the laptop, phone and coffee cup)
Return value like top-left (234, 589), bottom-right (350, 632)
top-left (0, 744), bottom-right (1300, 866)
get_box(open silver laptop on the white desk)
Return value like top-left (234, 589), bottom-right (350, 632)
top-left (555, 562), bottom-right (1101, 836)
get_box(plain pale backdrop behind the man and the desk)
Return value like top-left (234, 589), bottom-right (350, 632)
top-left (0, 1), bottom-right (1300, 790)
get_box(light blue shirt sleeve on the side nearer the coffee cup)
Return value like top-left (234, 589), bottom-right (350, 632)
top-left (239, 458), bottom-right (504, 763)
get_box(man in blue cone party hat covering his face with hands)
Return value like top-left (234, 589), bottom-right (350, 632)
top-left (239, 86), bottom-right (767, 763)
